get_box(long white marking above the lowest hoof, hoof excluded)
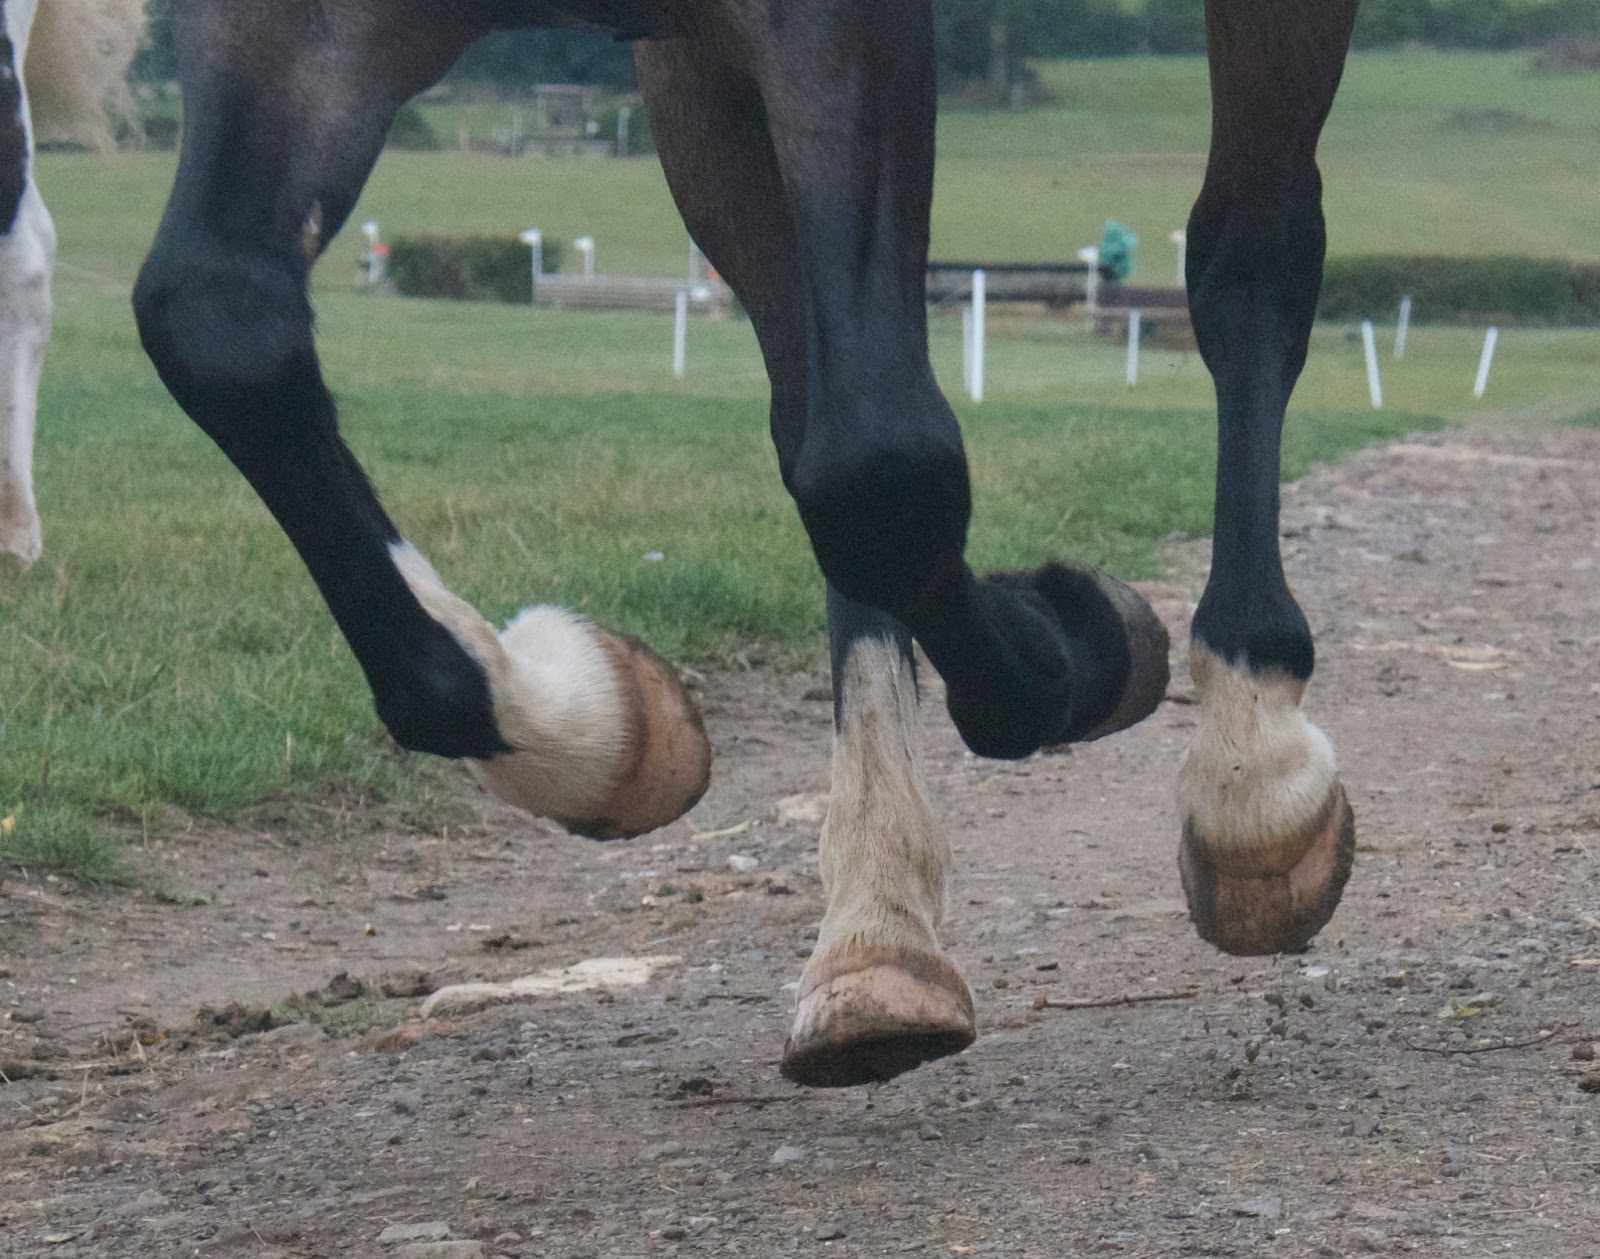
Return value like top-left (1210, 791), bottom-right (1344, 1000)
top-left (802, 638), bottom-right (950, 972)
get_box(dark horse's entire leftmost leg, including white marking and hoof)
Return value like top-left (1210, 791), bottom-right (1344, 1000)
top-left (134, 5), bottom-right (709, 837)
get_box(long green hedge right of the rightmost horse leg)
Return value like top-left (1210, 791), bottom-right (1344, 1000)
top-left (1318, 256), bottom-right (1600, 325)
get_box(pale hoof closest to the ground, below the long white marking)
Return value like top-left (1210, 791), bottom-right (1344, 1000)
top-left (781, 952), bottom-right (978, 1088)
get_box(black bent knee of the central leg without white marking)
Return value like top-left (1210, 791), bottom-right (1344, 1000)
top-left (786, 424), bottom-right (971, 611)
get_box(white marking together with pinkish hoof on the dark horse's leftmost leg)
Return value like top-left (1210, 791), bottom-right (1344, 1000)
top-left (390, 542), bottom-right (710, 838)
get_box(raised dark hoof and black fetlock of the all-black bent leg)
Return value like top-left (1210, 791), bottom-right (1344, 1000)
top-left (949, 563), bottom-right (1168, 758)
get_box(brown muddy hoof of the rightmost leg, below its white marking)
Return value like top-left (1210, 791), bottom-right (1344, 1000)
top-left (1178, 782), bottom-right (1355, 957)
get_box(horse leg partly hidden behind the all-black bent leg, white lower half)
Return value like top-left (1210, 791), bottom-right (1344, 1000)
top-left (638, 40), bottom-right (974, 1085)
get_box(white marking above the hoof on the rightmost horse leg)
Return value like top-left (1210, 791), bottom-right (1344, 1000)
top-left (1178, 643), bottom-right (1338, 873)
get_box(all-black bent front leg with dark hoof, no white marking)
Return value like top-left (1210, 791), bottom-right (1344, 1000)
top-left (755, 0), bottom-right (1166, 757)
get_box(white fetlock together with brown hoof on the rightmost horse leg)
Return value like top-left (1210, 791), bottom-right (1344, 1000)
top-left (1178, 643), bottom-right (1355, 955)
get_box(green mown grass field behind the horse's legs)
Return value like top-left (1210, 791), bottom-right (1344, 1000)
top-left (0, 54), bottom-right (1600, 877)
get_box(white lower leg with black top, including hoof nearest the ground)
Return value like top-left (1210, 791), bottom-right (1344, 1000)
top-left (782, 592), bottom-right (976, 1086)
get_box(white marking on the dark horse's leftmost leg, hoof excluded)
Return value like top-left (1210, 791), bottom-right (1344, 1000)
top-left (389, 541), bottom-right (629, 817)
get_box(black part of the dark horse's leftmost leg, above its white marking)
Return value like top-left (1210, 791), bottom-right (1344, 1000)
top-left (134, 6), bottom-right (506, 757)
